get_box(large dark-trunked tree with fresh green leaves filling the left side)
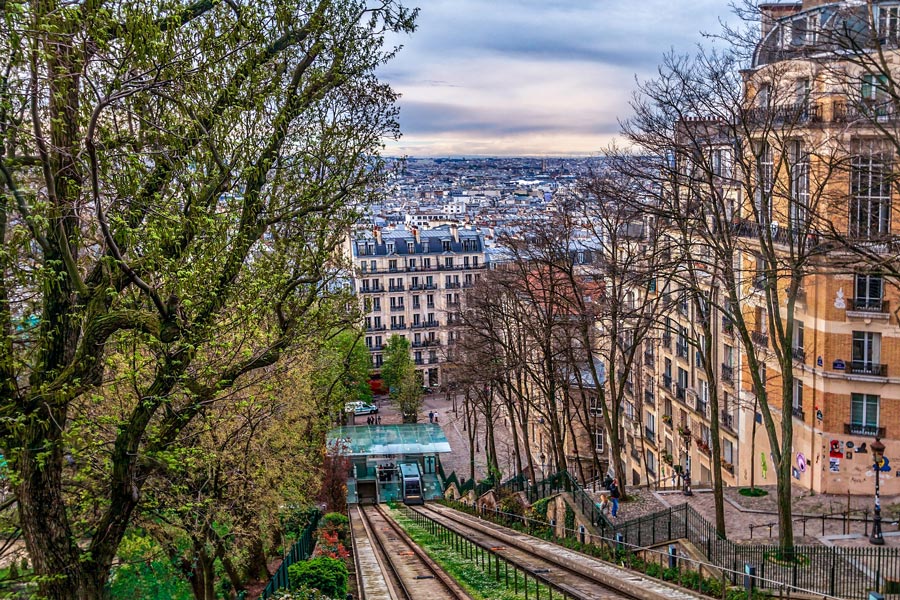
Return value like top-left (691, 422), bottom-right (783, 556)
top-left (0, 0), bottom-right (415, 600)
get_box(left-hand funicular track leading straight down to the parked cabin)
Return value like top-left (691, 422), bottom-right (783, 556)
top-left (356, 504), bottom-right (472, 600)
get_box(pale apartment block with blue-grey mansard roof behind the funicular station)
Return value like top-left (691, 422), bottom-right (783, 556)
top-left (349, 225), bottom-right (486, 388)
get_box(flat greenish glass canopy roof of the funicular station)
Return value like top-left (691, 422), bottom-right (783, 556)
top-left (328, 423), bottom-right (450, 456)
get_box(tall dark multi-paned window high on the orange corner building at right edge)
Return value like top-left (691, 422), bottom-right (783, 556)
top-left (850, 140), bottom-right (892, 238)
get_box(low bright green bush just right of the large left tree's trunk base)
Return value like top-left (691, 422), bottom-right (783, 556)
top-left (107, 532), bottom-right (193, 600)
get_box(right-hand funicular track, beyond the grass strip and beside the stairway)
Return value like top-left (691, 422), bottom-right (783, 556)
top-left (409, 505), bottom-right (697, 600)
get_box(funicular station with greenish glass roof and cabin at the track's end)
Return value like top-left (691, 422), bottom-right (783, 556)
top-left (328, 423), bottom-right (450, 504)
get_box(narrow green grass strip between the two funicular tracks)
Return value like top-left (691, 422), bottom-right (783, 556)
top-left (392, 511), bottom-right (549, 600)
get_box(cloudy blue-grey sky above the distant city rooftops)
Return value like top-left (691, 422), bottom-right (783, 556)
top-left (381, 0), bottom-right (730, 156)
